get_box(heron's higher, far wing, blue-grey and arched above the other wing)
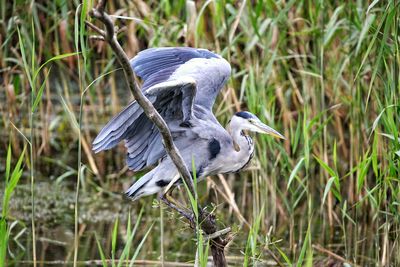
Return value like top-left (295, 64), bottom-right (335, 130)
top-left (131, 47), bottom-right (231, 111)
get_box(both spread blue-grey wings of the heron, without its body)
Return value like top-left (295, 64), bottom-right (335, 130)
top-left (93, 47), bottom-right (231, 170)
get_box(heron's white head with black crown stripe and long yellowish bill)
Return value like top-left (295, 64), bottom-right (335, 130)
top-left (231, 111), bottom-right (285, 139)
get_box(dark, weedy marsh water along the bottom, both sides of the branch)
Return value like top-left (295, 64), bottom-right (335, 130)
top-left (1, 181), bottom-right (373, 266)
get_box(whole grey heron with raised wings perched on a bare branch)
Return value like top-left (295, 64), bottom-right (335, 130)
top-left (93, 47), bottom-right (284, 200)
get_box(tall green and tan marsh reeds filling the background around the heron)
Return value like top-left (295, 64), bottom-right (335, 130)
top-left (0, 0), bottom-right (400, 266)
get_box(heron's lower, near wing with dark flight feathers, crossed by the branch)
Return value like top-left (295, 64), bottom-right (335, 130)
top-left (93, 77), bottom-right (196, 170)
